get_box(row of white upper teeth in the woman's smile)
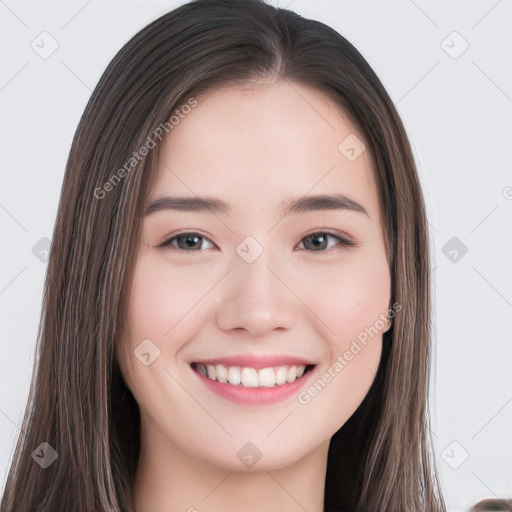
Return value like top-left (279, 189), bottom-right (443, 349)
top-left (196, 363), bottom-right (306, 388)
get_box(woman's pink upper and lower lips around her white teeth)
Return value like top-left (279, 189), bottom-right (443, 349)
top-left (192, 355), bottom-right (314, 405)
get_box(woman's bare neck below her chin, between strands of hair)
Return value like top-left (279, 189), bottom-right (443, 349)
top-left (133, 416), bottom-right (329, 512)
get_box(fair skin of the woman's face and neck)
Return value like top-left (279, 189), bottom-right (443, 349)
top-left (117, 82), bottom-right (391, 512)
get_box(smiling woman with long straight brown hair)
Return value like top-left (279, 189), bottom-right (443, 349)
top-left (1, 0), bottom-right (445, 512)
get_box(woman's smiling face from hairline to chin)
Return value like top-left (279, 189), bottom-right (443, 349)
top-left (117, 82), bottom-right (390, 471)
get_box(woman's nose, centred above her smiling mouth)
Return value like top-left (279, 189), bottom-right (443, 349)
top-left (216, 252), bottom-right (300, 337)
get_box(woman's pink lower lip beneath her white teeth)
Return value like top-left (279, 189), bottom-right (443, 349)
top-left (192, 368), bottom-right (315, 405)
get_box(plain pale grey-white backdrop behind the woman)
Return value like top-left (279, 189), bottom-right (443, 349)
top-left (0, 0), bottom-right (512, 511)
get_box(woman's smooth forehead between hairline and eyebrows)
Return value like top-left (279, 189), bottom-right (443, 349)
top-left (150, 81), bottom-right (378, 217)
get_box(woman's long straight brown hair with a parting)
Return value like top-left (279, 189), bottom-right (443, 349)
top-left (1, 0), bottom-right (445, 512)
